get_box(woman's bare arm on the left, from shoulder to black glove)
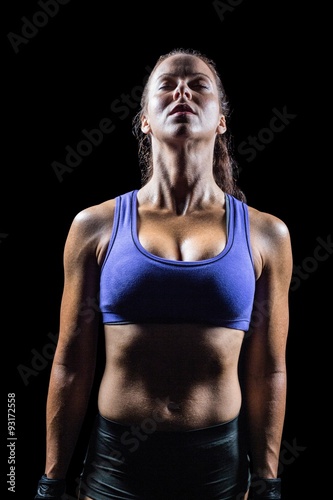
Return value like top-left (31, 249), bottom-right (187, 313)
top-left (45, 209), bottom-right (100, 479)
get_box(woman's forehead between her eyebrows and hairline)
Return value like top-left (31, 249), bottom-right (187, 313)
top-left (153, 54), bottom-right (215, 82)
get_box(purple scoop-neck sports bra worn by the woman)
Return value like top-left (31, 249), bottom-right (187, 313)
top-left (100, 190), bottom-right (255, 331)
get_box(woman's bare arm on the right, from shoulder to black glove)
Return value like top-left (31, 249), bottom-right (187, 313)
top-left (244, 212), bottom-right (292, 480)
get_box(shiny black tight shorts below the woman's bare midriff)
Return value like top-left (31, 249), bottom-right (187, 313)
top-left (80, 415), bottom-right (250, 500)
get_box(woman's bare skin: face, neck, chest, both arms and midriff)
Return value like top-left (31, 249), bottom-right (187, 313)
top-left (45, 52), bottom-right (292, 500)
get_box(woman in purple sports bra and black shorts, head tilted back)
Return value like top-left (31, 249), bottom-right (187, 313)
top-left (35, 49), bottom-right (292, 500)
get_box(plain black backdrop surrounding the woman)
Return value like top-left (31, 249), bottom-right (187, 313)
top-left (0, 0), bottom-right (332, 500)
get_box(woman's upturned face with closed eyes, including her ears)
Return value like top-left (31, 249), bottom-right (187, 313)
top-left (142, 54), bottom-right (226, 144)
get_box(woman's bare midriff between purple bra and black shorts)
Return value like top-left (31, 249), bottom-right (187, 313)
top-left (98, 324), bottom-right (244, 431)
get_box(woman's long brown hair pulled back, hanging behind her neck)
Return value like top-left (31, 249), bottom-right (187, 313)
top-left (132, 48), bottom-right (246, 202)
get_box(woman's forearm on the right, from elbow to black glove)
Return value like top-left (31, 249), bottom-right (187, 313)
top-left (246, 372), bottom-right (286, 478)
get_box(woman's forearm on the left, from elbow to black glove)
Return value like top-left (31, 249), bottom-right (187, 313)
top-left (45, 365), bottom-right (93, 479)
